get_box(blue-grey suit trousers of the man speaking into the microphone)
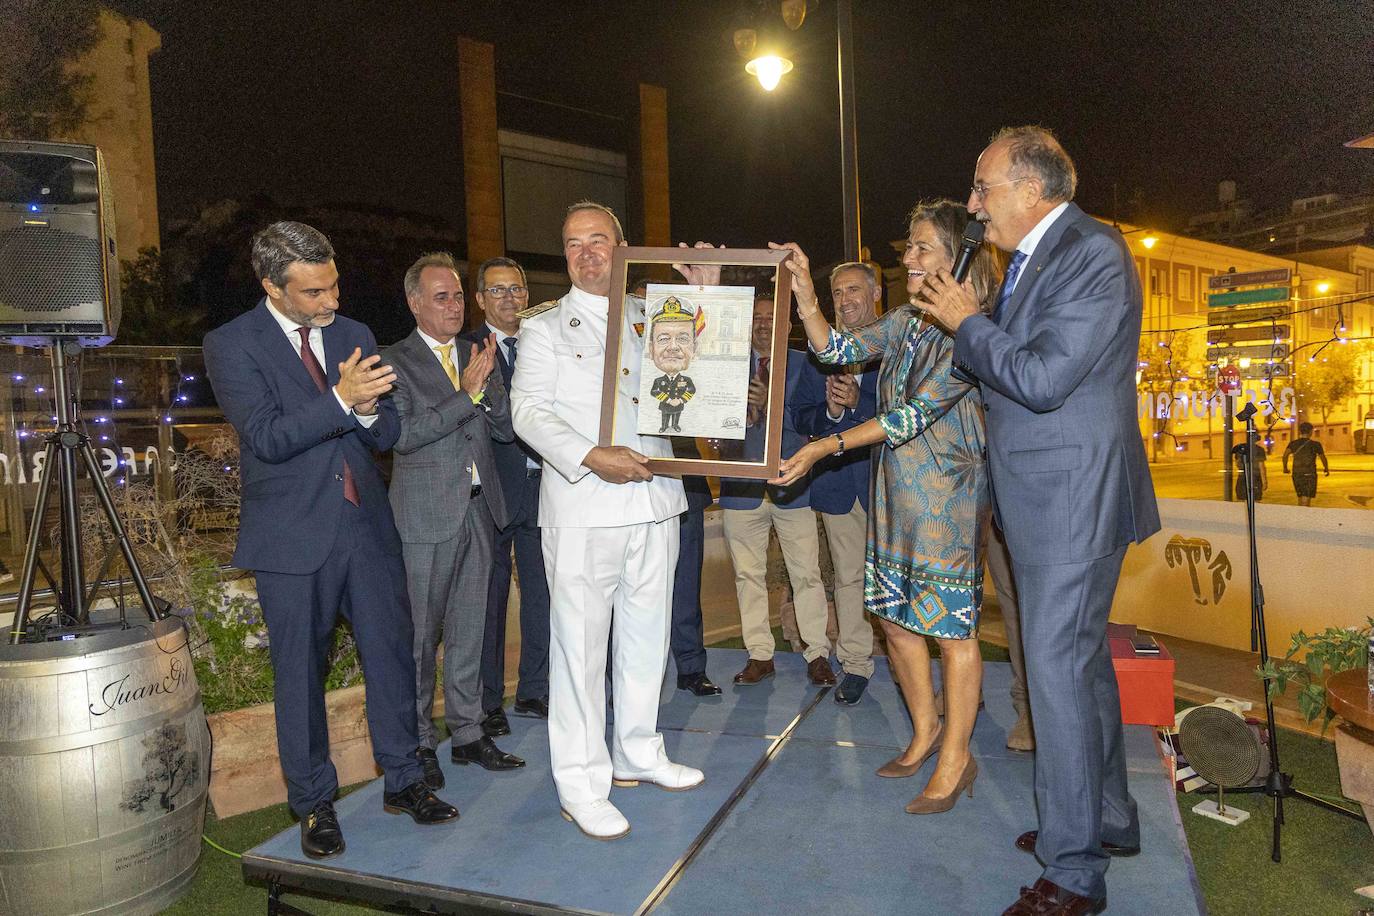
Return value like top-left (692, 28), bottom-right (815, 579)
top-left (1013, 548), bottom-right (1140, 897)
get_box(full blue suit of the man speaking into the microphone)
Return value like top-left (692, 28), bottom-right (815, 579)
top-left (954, 203), bottom-right (1160, 897)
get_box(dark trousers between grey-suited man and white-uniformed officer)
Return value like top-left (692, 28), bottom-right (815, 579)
top-left (482, 477), bottom-right (550, 711)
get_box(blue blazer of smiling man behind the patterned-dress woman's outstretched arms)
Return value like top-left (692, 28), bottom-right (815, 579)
top-left (793, 356), bottom-right (878, 515)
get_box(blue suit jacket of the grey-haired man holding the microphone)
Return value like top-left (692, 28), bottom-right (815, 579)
top-left (954, 203), bottom-right (1160, 566)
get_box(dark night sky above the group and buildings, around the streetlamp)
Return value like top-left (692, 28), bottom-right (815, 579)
top-left (113, 0), bottom-right (1374, 264)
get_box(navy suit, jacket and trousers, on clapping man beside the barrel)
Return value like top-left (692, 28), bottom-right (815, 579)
top-left (205, 299), bottom-right (422, 816)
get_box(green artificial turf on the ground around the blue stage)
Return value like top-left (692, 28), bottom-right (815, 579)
top-left (165, 642), bottom-right (1374, 916)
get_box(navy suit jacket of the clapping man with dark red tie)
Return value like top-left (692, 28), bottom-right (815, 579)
top-left (205, 299), bottom-right (401, 574)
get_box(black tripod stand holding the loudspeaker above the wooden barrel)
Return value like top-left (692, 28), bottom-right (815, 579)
top-left (10, 338), bottom-right (166, 644)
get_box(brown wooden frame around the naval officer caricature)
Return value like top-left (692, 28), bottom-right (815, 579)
top-left (596, 246), bottom-right (791, 481)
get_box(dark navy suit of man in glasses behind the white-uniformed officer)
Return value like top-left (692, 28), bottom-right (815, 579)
top-left (459, 324), bottom-right (550, 713)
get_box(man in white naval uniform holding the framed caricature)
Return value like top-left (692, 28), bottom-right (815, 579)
top-left (511, 202), bottom-right (703, 839)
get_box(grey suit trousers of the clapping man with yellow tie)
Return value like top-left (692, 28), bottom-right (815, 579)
top-left (404, 496), bottom-right (496, 750)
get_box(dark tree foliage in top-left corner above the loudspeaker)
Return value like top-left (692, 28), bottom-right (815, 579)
top-left (0, 0), bottom-right (100, 140)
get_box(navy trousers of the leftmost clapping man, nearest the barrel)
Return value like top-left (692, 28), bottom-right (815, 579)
top-left (257, 505), bottom-right (423, 816)
